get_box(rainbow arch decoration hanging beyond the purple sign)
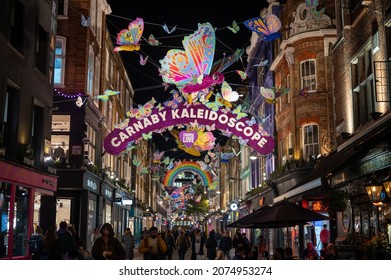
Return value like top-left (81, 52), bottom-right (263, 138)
top-left (163, 161), bottom-right (212, 186)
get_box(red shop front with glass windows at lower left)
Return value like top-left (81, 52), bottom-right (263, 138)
top-left (0, 159), bottom-right (57, 259)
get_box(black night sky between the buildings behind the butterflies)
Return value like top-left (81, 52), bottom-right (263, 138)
top-left (107, 0), bottom-right (268, 104)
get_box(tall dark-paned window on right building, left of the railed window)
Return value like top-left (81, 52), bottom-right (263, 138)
top-left (350, 45), bottom-right (375, 129)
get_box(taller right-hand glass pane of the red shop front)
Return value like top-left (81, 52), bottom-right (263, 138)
top-left (12, 186), bottom-right (31, 256)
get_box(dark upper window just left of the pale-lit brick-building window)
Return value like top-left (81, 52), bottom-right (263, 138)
top-left (35, 23), bottom-right (49, 75)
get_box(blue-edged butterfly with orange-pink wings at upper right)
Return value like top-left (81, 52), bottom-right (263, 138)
top-left (244, 14), bottom-right (281, 42)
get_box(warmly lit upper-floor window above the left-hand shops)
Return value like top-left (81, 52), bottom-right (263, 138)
top-left (51, 115), bottom-right (70, 162)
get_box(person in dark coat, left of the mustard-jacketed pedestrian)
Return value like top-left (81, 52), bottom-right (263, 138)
top-left (91, 223), bottom-right (125, 260)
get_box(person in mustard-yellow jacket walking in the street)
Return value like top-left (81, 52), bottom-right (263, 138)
top-left (138, 227), bottom-right (167, 260)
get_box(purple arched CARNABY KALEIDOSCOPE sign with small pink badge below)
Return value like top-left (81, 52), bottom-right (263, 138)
top-left (104, 104), bottom-right (274, 155)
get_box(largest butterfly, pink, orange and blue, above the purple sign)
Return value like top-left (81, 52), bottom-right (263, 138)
top-left (160, 23), bottom-right (242, 93)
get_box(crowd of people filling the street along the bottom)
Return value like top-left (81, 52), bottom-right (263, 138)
top-left (30, 221), bottom-right (337, 260)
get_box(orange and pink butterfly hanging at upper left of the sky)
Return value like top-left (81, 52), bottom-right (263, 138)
top-left (114, 18), bottom-right (144, 52)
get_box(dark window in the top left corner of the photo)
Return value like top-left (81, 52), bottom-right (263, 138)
top-left (9, 0), bottom-right (24, 51)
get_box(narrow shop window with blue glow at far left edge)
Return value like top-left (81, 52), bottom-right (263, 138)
top-left (0, 182), bottom-right (11, 258)
